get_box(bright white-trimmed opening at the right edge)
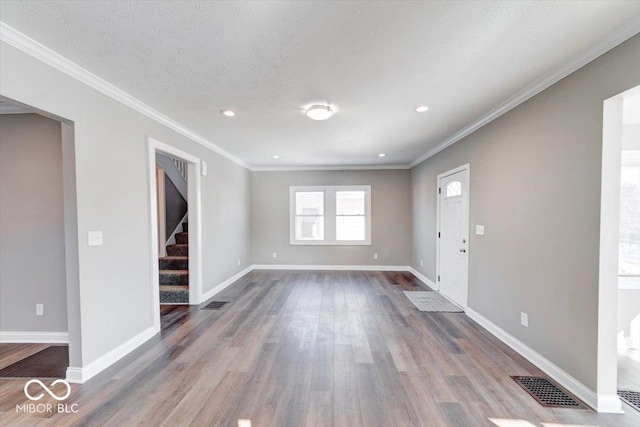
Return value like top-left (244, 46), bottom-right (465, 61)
top-left (597, 86), bottom-right (640, 413)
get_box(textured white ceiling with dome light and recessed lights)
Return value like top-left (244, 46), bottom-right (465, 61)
top-left (0, 1), bottom-right (640, 166)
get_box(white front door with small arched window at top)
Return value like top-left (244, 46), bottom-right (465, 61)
top-left (438, 166), bottom-right (469, 307)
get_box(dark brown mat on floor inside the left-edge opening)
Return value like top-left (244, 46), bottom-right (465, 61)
top-left (0, 345), bottom-right (69, 378)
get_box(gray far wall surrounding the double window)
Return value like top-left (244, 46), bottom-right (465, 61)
top-left (251, 170), bottom-right (411, 265)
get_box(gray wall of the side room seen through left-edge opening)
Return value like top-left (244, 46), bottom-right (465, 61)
top-left (0, 114), bottom-right (67, 332)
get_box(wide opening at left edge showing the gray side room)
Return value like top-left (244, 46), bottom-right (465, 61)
top-left (0, 97), bottom-right (82, 382)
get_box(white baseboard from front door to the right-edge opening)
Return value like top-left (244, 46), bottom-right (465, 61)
top-left (466, 307), bottom-right (623, 414)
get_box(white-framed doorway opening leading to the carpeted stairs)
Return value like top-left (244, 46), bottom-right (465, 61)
top-left (148, 138), bottom-right (202, 331)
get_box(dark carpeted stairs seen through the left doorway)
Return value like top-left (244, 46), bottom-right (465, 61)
top-left (159, 223), bottom-right (189, 304)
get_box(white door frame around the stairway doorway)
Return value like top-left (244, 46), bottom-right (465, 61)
top-left (147, 137), bottom-right (202, 331)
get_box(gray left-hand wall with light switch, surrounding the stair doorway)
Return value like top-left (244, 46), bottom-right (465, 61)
top-left (0, 43), bottom-right (251, 366)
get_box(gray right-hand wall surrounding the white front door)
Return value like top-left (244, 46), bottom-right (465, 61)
top-left (411, 36), bottom-right (640, 390)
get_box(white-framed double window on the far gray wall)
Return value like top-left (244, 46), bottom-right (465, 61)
top-left (289, 185), bottom-right (371, 245)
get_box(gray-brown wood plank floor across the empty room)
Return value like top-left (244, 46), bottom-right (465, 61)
top-left (0, 271), bottom-right (640, 427)
